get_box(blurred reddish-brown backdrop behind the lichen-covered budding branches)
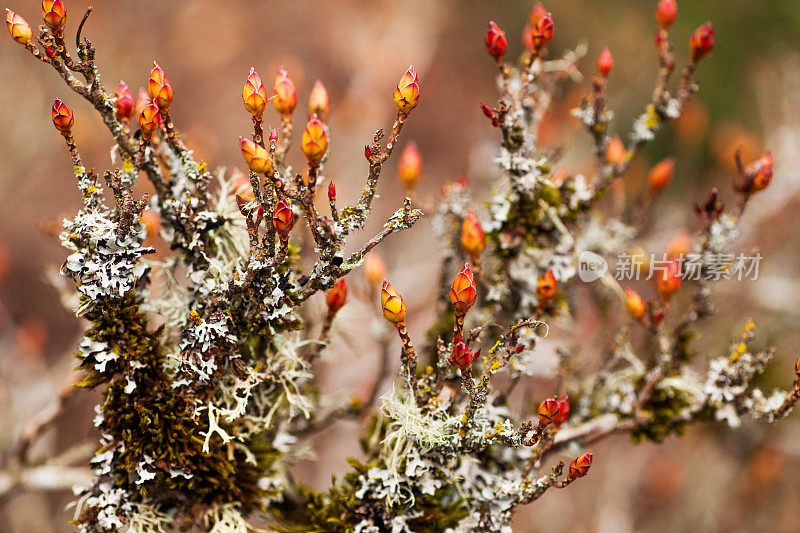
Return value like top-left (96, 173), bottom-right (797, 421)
top-left (0, 0), bottom-right (800, 533)
